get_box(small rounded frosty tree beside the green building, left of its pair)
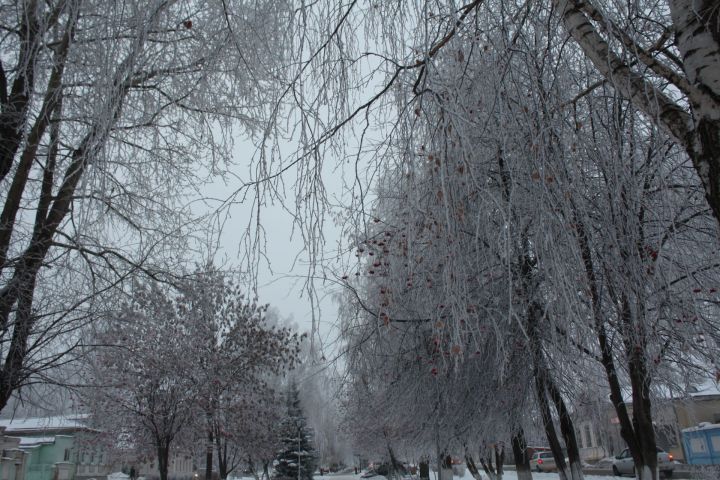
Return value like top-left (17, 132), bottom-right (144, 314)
top-left (84, 284), bottom-right (202, 480)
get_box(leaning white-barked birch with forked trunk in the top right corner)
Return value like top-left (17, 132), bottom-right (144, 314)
top-left (553, 0), bottom-right (720, 227)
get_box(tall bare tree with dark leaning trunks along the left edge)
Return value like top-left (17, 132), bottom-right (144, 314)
top-left (0, 0), bottom-right (288, 407)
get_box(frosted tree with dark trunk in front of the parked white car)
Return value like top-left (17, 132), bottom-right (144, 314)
top-left (560, 94), bottom-right (718, 478)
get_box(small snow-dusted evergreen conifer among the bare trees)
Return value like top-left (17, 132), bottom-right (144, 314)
top-left (275, 381), bottom-right (317, 480)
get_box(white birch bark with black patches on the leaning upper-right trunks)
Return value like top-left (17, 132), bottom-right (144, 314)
top-left (554, 0), bottom-right (720, 227)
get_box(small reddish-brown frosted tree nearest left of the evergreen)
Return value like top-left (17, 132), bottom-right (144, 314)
top-left (181, 266), bottom-right (304, 480)
